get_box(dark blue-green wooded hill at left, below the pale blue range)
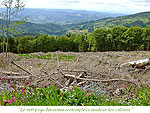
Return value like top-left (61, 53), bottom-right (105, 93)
top-left (0, 20), bottom-right (66, 36)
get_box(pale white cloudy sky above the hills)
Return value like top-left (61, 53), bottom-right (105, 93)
top-left (22, 0), bottom-right (150, 14)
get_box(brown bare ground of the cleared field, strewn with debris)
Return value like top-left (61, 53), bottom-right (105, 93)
top-left (0, 51), bottom-right (150, 93)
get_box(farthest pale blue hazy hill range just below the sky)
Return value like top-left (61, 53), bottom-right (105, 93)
top-left (8, 8), bottom-right (122, 25)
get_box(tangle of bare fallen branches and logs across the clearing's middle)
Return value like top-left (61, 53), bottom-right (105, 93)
top-left (1, 62), bottom-right (136, 88)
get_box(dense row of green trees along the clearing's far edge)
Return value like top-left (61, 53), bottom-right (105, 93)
top-left (0, 26), bottom-right (150, 53)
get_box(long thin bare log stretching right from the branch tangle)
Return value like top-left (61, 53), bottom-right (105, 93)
top-left (65, 74), bottom-right (136, 86)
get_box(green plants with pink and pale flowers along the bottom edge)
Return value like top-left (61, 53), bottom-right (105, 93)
top-left (0, 77), bottom-right (150, 106)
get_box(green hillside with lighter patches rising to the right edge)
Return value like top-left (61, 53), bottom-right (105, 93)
top-left (72, 12), bottom-right (150, 31)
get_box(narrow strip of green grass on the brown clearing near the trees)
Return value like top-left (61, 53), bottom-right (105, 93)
top-left (17, 54), bottom-right (75, 61)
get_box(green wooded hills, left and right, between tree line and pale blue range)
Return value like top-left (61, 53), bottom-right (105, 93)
top-left (0, 12), bottom-right (150, 36)
